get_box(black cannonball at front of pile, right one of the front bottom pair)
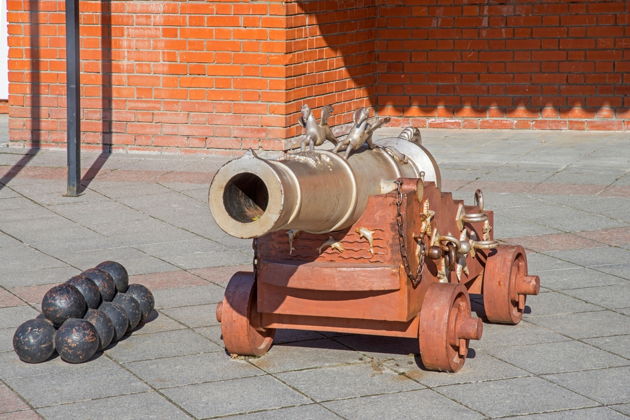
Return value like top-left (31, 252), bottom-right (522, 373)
top-left (55, 318), bottom-right (100, 363)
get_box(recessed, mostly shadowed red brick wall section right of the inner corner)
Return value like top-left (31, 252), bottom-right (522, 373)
top-left (378, 0), bottom-right (630, 130)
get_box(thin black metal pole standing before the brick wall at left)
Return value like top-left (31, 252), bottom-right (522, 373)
top-left (66, 0), bottom-right (81, 197)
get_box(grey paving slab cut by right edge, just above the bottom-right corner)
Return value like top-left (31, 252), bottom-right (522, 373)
top-left (545, 366), bottom-right (630, 405)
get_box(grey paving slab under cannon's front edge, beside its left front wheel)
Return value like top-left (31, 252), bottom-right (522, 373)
top-left (252, 339), bottom-right (361, 373)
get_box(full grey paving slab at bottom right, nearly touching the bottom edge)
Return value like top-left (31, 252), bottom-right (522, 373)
top-left (439, 378), bottom-right (598, 417)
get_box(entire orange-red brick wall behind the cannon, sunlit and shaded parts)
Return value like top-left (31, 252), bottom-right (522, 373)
top-left (8, 0), bottom-right (630, 151)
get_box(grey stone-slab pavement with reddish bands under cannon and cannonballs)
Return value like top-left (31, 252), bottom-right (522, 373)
top-left (0, 126), bottom-right (630, 419)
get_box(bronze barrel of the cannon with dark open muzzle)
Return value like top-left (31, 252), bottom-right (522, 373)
top-left (208, 138), bottom-right (440, 238)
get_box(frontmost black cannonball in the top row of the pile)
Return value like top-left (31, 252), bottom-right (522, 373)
top-left (42, 284), bottom-right (87, 326)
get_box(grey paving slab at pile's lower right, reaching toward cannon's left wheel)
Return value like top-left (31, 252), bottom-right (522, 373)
top-left (107, 330), bottom-right (220, 363)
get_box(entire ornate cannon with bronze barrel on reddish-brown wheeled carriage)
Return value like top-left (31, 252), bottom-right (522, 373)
top-left (209, 109), bottom-right (540, 372)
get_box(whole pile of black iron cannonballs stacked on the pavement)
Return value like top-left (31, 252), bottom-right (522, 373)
top-left (13, 261), bottom-right (155, 363)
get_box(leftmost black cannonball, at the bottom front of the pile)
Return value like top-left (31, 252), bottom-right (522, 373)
top-left (13, 318), bottom-right (55, 363)
